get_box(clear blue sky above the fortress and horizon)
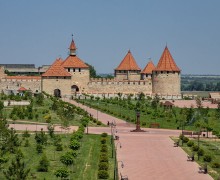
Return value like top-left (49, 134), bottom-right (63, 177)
top-left (0, 0), bottom-right (220, 74)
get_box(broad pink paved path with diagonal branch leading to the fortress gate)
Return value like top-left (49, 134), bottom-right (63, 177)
top-left (69, 100), bottom-right (212, 180)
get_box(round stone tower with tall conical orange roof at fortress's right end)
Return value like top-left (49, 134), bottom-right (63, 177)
top-left (152, 46), bottom-right (181, 95)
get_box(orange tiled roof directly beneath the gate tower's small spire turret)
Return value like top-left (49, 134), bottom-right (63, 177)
top-left (62, 56), bottom-right (89, 68)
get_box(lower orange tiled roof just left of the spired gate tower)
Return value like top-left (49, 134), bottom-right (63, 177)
top-left (42, 58), bottom-right (71, 77)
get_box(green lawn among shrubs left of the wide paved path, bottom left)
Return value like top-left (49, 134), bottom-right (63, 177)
top-left (0, 135), bottom-right (114, 180)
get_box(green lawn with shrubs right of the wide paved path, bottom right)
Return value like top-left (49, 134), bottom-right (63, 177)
top-left (172, 138), bottom-right (220, 180)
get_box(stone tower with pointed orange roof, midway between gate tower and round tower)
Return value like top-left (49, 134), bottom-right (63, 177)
top-left (115, 50), bottom-right (141, 80)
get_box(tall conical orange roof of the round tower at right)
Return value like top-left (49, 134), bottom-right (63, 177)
top-left (154, 46), bottom-right (180, 72)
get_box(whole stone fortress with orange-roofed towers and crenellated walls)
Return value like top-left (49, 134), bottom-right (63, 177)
top-left (0, 39), bottom-right (181, 99)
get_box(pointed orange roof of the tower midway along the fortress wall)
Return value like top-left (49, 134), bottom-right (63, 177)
top-left (115, 50), bottom-right (141, 71)
